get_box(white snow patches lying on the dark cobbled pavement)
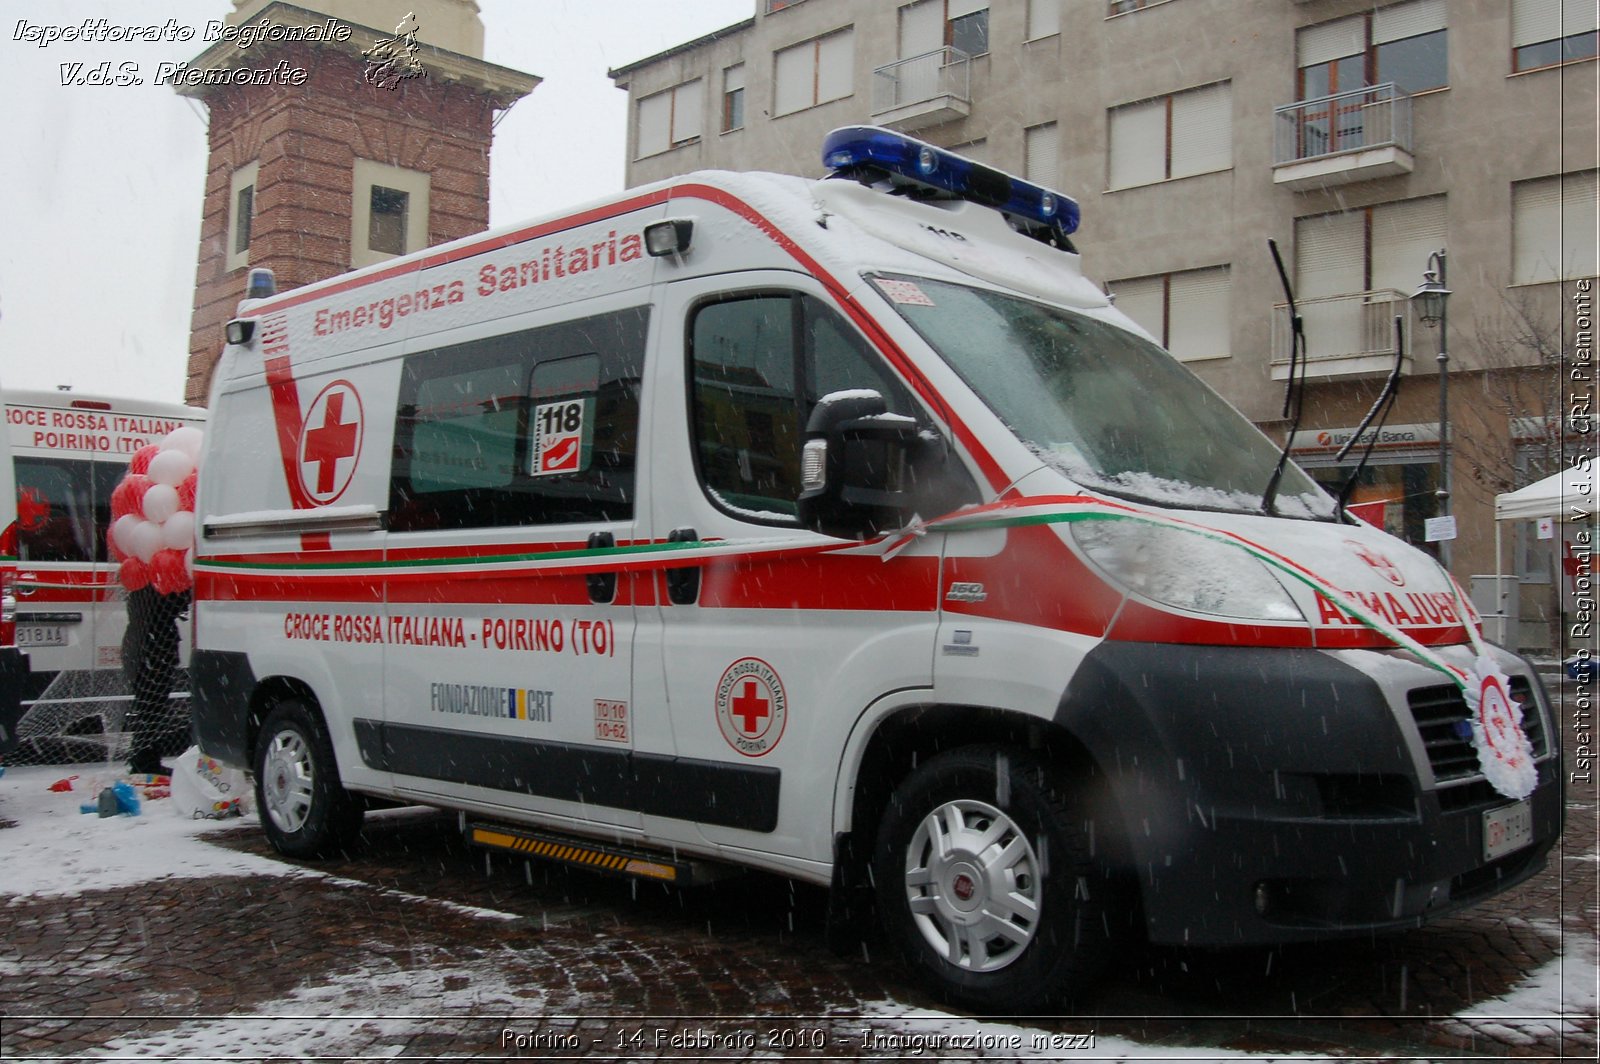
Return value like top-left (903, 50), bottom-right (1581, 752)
top-left (0, 766), bottom-right (1595, 1061)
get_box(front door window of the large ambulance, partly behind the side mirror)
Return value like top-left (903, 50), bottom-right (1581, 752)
top-left (690, 293), bottom-right (920, 523)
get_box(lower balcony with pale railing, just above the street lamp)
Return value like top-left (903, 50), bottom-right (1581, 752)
top-left (1272, 288), bottom-right (1413, 381)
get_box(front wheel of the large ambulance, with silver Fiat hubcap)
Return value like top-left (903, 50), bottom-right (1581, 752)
top-left (872, 746), bottom-right (1114, 1014)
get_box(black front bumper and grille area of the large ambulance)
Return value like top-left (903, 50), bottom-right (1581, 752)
top-left (1058, 643), bottom-right (1563, 946)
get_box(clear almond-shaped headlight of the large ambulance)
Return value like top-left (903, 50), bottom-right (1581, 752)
top-left (1069, 518), bottom-right (1306, 622)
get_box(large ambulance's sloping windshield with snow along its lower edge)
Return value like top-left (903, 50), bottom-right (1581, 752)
top-left (874, 277), bottom-right (1334, 518)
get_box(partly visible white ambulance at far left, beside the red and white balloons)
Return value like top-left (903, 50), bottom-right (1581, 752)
top-left (0, 389), bottom-right (206, 755)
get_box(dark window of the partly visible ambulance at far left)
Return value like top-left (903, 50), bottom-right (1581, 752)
top-left (16, 458), bottom-right (119, 562)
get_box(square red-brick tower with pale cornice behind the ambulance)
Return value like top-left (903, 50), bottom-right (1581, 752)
top-left (174, 0), bottom-right (539, 405)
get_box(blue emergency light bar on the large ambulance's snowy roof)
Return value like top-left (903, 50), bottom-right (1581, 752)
top-left (822, 126), bottom-right (1078, 234)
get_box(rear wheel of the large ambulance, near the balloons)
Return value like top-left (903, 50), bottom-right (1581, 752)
top-left (256, 699), bottom-right (366, 858)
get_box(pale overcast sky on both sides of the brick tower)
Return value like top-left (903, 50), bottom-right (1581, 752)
top-left (0, 0), bottom-right (755, 400)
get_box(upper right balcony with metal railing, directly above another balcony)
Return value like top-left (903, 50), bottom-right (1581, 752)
top-left (1272, 82), bottom-right (1413, 192)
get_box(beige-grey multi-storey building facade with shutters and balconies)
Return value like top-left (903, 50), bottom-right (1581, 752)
top-left (611, 0), bottom-right (1600, 648)
